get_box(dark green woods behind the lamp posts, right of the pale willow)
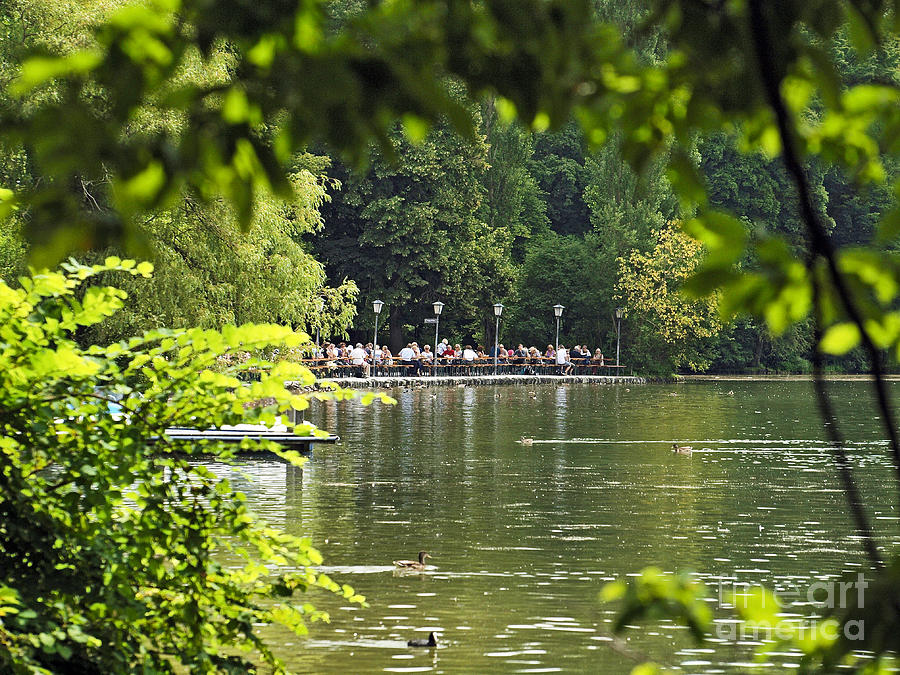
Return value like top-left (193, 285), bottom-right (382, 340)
top-left (307, 2), bottom-right (900, 374)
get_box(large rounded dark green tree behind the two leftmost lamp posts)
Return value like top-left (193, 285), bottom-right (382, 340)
top-left (313, 125), bottom-right (500, 350)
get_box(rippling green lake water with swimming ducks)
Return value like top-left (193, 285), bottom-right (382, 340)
top-left (229, 381), bottom-right (900, 673)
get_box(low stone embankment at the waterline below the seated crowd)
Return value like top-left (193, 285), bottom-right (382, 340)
top-left (289, 375), bottom-right (647, 389)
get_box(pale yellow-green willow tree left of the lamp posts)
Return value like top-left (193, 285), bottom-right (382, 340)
top-left (81, 171), bottom-right (357, 344)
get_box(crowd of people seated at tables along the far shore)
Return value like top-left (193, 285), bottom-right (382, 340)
top-left (306, 338), bottom-right (607, 377)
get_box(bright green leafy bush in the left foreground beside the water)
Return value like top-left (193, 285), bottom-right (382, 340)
top-left (0, 257), bottom-right (390, 673)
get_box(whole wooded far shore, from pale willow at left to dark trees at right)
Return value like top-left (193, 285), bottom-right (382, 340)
top-left (0, 0), bottom-right (900, 374)
